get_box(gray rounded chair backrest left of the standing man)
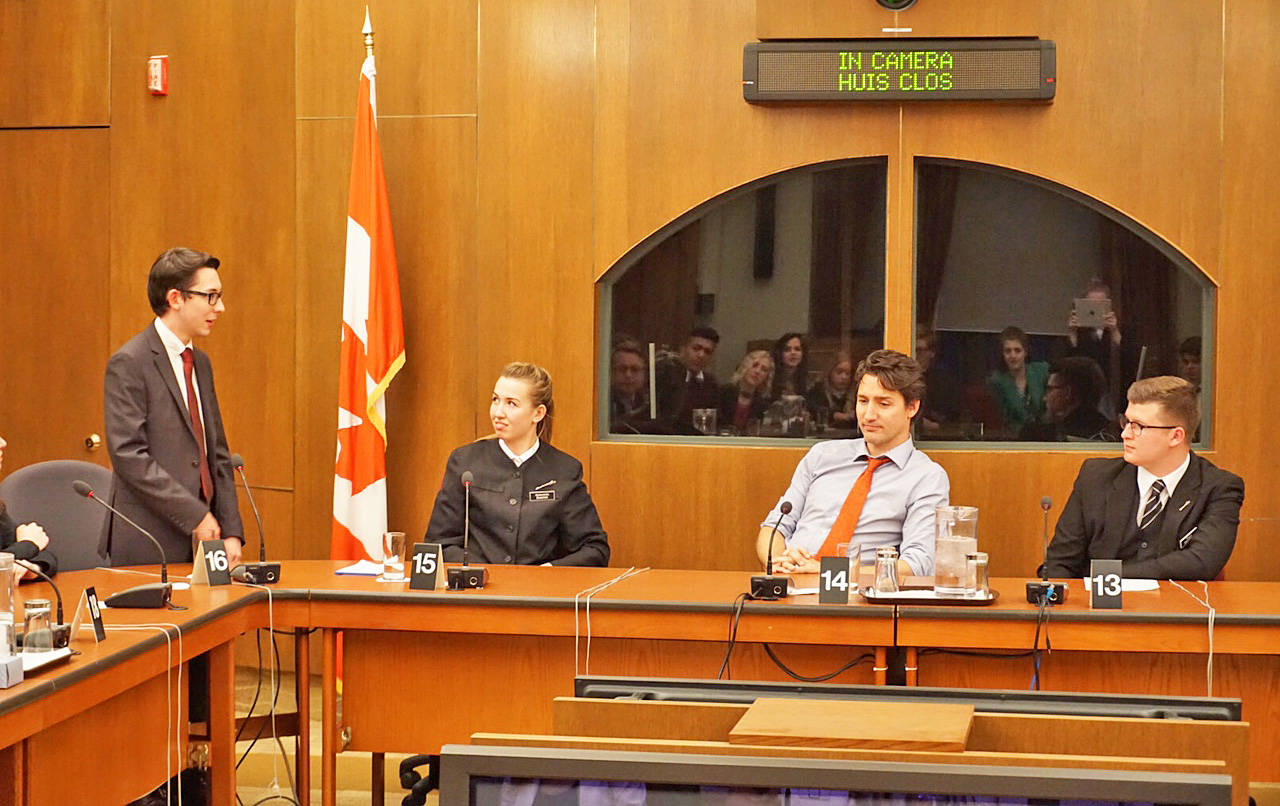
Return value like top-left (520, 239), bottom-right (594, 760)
top-left (0, 459), bottom-right (111, 571)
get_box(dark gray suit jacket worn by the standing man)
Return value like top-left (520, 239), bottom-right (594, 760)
top-left (104, 322), bottom-right (244, 565)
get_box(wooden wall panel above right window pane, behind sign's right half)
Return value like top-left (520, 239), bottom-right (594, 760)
top-left (902, 0), bottom-right (1222, 277)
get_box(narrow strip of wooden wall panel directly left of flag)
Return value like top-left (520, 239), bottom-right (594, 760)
top-left (293, 118), bottom-right (348, 559)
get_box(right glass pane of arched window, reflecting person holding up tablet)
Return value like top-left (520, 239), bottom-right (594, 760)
top-left (915, 159), bottom-right (1213, 448)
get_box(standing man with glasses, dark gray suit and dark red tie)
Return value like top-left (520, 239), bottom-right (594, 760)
top-left (105, 247), bottom-right (244, 565)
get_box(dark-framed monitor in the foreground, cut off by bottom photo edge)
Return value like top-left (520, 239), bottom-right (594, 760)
top-left (440, 745), bottom-right (1231, 806)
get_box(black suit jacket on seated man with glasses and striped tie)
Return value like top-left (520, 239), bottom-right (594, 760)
top-left (1047, 454), bottom-right (1244, 580)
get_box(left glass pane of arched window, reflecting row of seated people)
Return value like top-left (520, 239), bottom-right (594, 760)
top-left (599, 157), bottom-right (887, 440)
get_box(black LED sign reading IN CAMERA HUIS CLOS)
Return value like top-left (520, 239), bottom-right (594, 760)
top-left (742, 38), bottom-right (1057, 104)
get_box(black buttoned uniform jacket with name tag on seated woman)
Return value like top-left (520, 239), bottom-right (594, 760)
top-left (426, 439), bottom-right (609, 565)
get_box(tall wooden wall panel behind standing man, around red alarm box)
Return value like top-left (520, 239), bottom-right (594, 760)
top-left (110, 0), bottom-right (294, 487)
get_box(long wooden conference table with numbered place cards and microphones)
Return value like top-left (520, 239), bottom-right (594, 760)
top-left (0, 560), bottom-right (1280, 803)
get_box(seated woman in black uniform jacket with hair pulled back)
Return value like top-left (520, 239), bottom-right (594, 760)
top-left (426, 362), bottom-right (609, 565)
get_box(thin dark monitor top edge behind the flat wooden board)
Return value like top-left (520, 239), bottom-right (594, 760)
top-left (573, 676), bottom-right (1240, 722)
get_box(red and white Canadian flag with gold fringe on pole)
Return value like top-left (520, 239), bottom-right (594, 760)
top-left (329, 40), bottom-right (404, 560)
